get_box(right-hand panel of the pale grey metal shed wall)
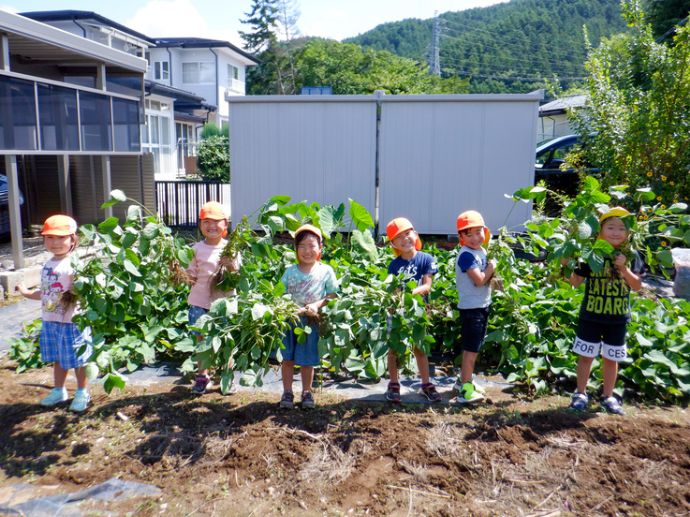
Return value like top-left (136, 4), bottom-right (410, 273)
top-left (379, 95), bottom-right (538, 234)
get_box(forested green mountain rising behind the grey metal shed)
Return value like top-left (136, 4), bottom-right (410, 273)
top-left (345, 0), bottom-right (626, 93)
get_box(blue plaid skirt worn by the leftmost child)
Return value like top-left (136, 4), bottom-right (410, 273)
top-left (40, 321), bottom-right (92, 370)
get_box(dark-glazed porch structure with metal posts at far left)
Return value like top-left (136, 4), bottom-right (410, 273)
top-left (0, 10), bottom-right (146, 270)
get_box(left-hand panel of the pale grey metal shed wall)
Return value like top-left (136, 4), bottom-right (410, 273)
top-left (230, 96), bottom-right (376, 225)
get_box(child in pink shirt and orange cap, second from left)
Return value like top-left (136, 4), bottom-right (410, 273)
top-left (187, 201), bottom-right (241, 395)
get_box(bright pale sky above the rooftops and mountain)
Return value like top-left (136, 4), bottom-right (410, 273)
top-left (0, 0), bottom-right (506, 44)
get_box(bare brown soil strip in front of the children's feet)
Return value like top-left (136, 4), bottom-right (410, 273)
top-left (0, 361), bottom-right (690, 516)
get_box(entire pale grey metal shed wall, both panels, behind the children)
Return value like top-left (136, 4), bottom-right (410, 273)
top-left (226, 93), bottom-right (542, 234)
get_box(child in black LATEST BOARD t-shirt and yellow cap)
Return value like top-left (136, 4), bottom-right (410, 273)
top-left (568, 207), bottom-right (643, 415)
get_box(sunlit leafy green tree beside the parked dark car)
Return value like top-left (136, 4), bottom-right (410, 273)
top-left (575, 0), bottom-right (690, 204)
